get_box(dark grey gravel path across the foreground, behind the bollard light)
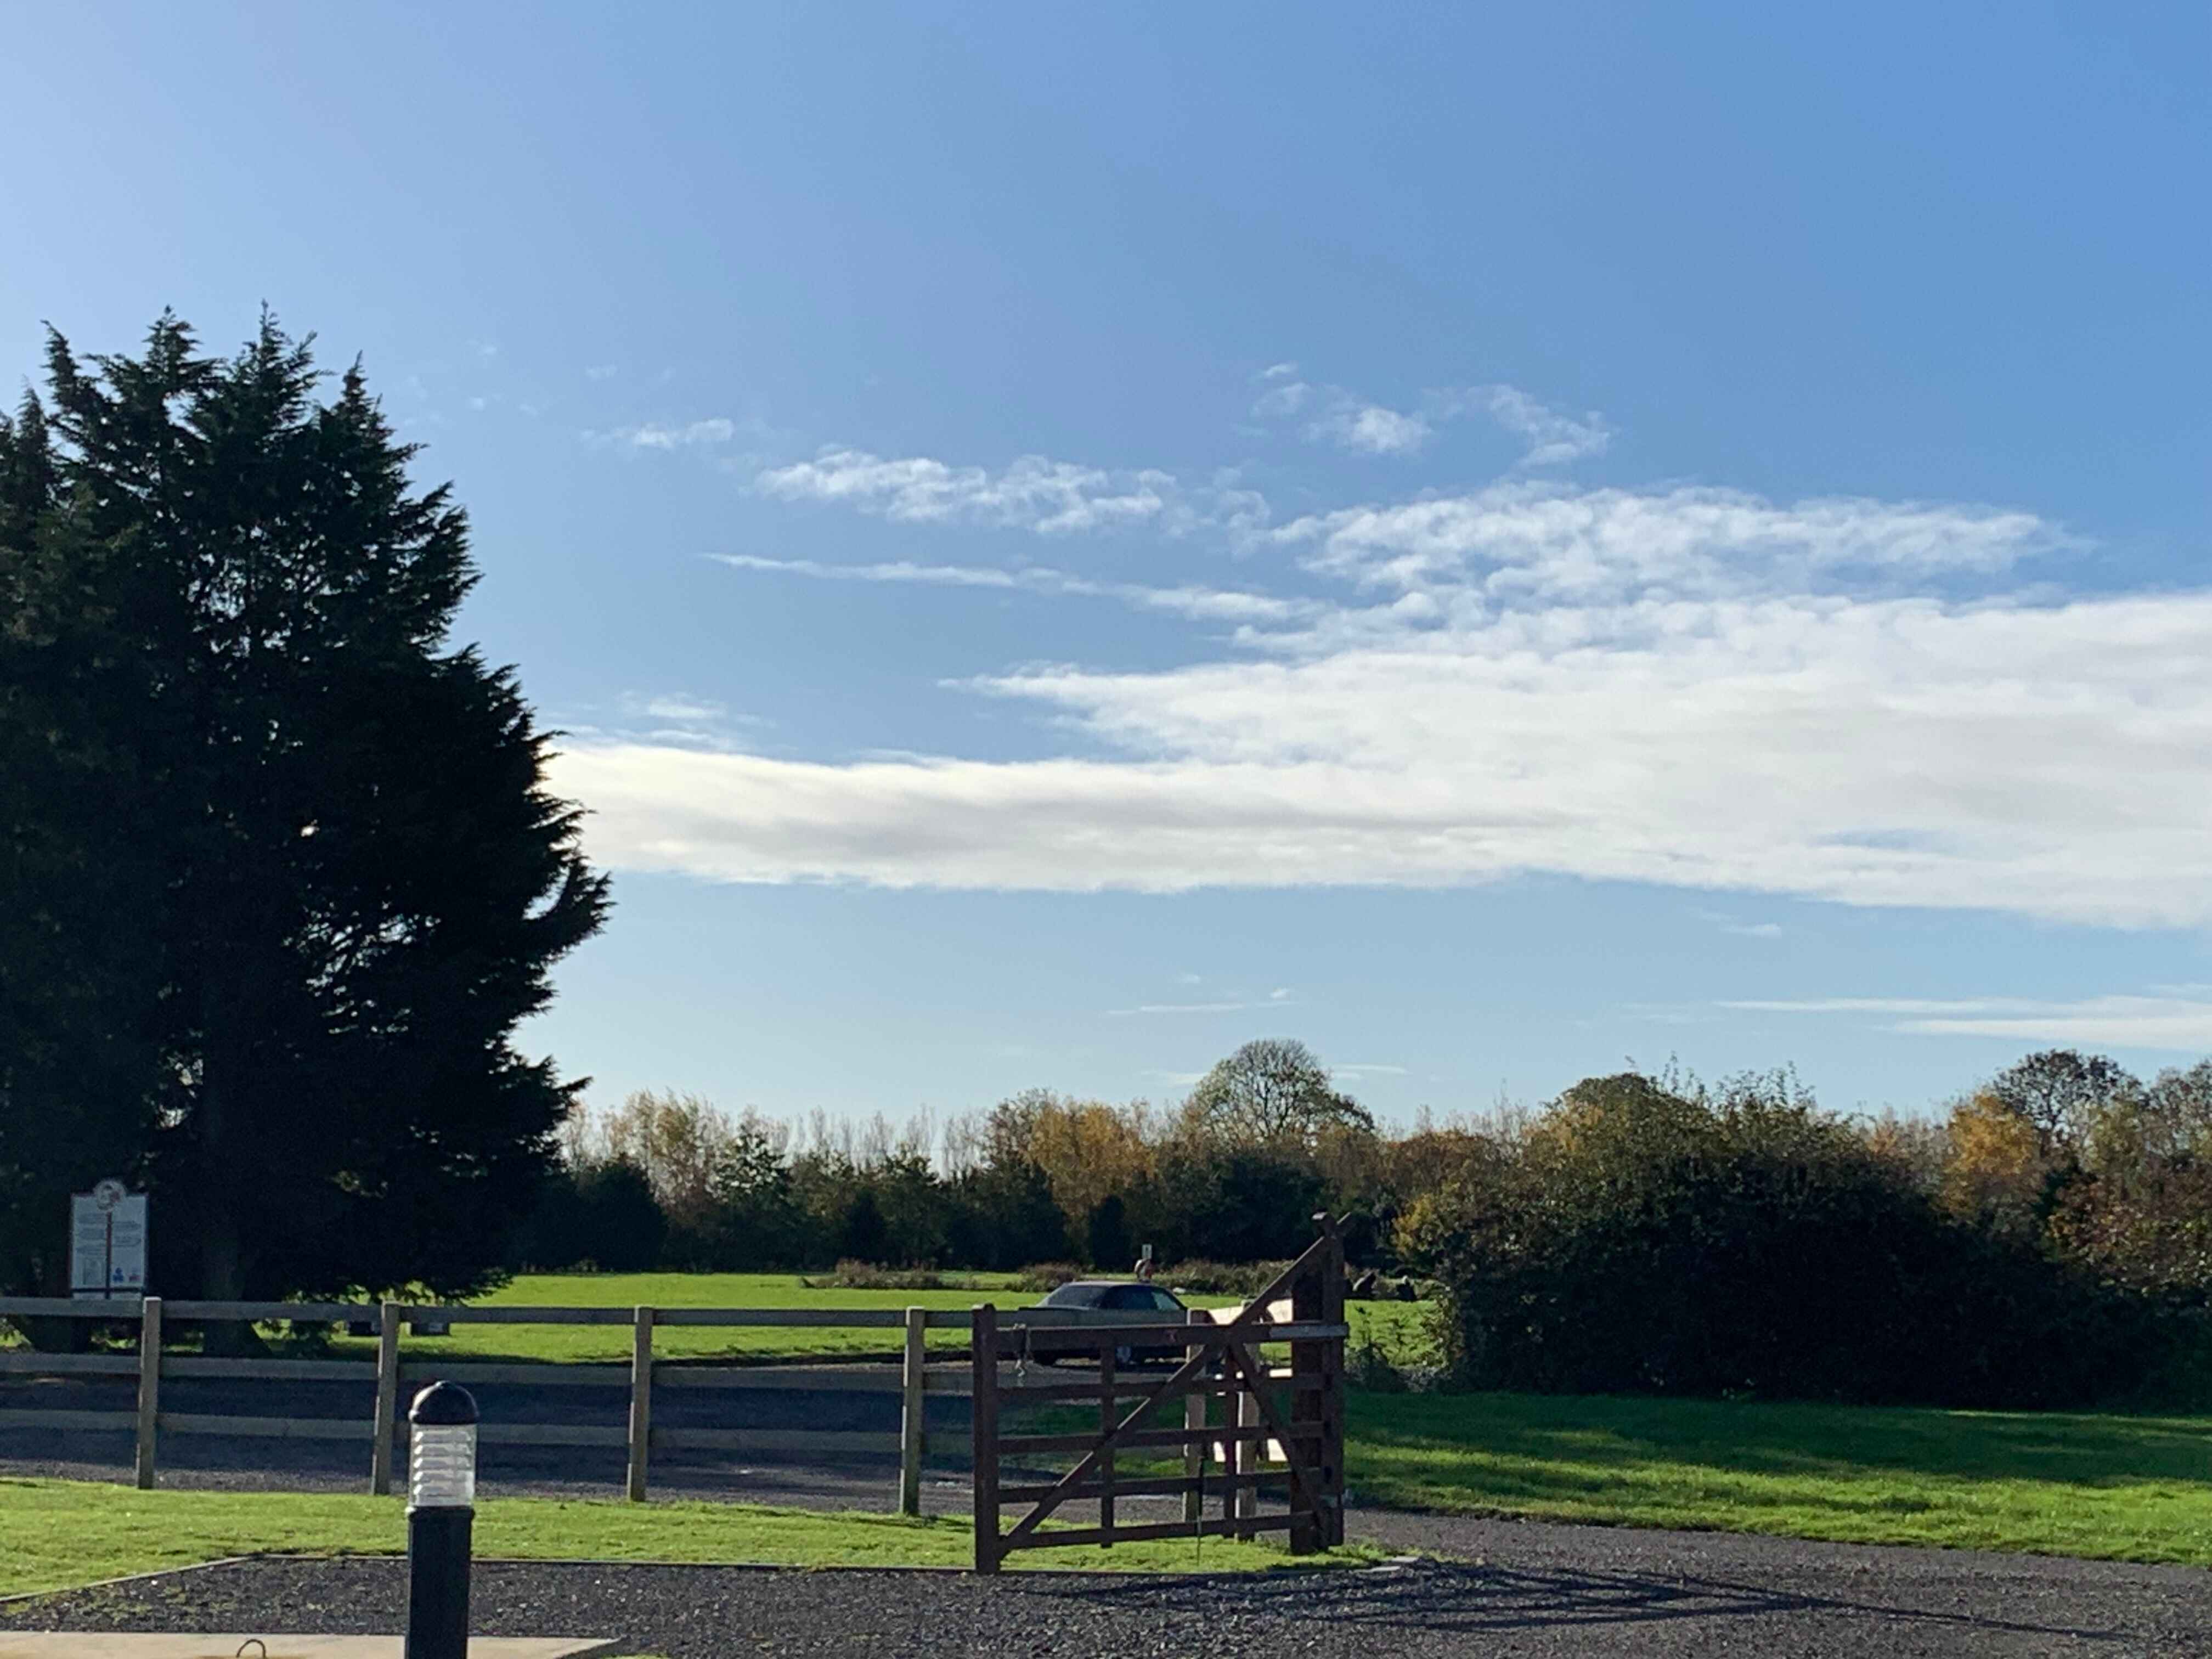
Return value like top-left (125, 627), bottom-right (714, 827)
top-left (0, 1511), bottom-right (2212, 1659)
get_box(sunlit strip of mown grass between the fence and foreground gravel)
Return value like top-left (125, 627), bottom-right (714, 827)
top-left (0, 1480), bottom-right (1374, 1595)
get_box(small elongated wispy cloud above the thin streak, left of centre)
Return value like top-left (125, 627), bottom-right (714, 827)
top-left (754, 449), bottom-right (1265, 535)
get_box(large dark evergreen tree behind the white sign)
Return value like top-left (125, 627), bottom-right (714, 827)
top-left (0, 317), bottom-right (608, 1299)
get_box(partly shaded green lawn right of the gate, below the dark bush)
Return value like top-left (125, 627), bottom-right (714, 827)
top-left (1345, 1393), bottom-right (2212, 1566)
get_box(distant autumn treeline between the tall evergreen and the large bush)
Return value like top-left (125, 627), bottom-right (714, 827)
top-left (515, 1042), bottom-right (1420, 1272)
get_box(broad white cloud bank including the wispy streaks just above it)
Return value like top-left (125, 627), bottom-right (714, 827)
top-left (557, 436), bottom-right (2212, 929)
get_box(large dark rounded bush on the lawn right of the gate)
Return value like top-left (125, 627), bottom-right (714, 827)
top-left (1400, 1075), bottom-right (2148, 1404)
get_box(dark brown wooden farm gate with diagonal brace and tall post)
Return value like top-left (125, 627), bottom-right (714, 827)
top-left (969, 1215), bottom-right (1347, 1573)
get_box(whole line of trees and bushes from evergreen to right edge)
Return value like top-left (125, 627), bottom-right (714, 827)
top-left (515, 1042), bottom-right (2212, 1404)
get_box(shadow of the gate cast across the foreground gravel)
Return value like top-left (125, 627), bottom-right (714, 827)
top-left (1022, 1562), bottom-right (2124, 1641)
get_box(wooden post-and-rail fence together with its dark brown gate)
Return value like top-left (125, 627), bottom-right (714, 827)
top-left (0, 1223), bottom-right (1345, 1571)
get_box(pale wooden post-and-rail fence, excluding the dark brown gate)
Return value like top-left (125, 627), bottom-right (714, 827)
top-left (0, 1296), bottom-right (1265, 1515)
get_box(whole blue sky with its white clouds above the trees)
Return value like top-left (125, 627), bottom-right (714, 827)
top-left (0, 4), bottom-right (2212, 1117)
